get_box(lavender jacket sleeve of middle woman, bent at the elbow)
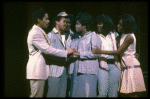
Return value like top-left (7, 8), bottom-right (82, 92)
top-left (80, 33), bottom-right (101, 59)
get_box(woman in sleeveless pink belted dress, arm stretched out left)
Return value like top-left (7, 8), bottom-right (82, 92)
top-left (92, 14), bottom-right (146, 97)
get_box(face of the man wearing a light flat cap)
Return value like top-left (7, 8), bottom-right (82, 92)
top-left (56, 17), bottom-right (67, 32)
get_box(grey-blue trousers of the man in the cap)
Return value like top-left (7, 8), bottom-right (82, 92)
top-left (47, 71), bottom-right (67, 97)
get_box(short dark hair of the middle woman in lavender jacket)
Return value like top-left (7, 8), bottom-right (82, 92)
top-left (76, 12), bottom-right (93, 31)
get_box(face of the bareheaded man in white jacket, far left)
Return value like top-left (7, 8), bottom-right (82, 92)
top-left (38, 13), bottom-right (50, 29)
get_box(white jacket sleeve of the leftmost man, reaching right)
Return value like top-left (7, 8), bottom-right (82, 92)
top-left (32, 32), bottom-right (68, 58)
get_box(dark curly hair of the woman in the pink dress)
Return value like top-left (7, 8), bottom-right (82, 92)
top-left (119, 14), bottom-right (137, 33)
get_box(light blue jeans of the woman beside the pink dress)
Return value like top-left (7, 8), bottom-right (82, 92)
top-left (97, 64), bottom-right (120, 97)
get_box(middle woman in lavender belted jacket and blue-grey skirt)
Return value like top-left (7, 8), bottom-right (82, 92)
top-left (70, 12), bottom-right (101, 97)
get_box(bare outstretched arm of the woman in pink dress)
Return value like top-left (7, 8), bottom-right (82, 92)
top-left (92, 35), bottom-right (133, 55)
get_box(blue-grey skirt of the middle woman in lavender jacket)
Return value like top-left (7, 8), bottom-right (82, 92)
top-left (70, 74), bottom-right (97, 97)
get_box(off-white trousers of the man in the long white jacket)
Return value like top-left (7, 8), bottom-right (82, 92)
top-left (30, 80), bottom-right (45, 98)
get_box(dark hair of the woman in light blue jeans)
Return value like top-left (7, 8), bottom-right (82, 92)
top-left (95, 14), bottom-right (115, 34)
